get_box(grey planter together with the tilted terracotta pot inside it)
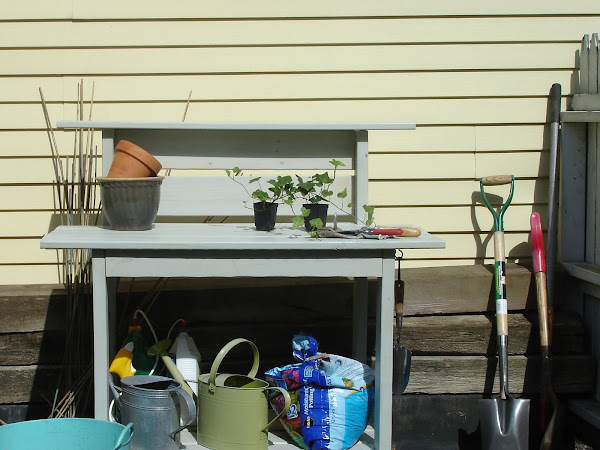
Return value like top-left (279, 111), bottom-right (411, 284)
top-left (98, 140), bottom-right (164, 230)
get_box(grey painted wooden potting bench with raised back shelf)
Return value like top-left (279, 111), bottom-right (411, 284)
top-left (41, 121), bottom-right (445, 449)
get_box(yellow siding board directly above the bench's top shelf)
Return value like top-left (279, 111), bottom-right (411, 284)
top-left (0, 98), bottom-right (547, 129)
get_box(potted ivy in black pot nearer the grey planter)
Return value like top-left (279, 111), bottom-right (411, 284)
top-left (225, 167), bottom-right (296, 231)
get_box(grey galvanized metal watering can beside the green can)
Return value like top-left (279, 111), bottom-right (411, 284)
top-left (111, 375), bottom-right (196, 450)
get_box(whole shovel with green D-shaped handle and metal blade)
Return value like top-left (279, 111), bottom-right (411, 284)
top-left (479, 175), bottom-right (529, 450)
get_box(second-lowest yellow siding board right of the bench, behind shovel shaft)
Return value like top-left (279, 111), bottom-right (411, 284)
top-left (374, 202), bottom-right (548, 233)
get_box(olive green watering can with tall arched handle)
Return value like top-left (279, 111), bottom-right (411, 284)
top-left (197, 338), bottom-right (291, 450)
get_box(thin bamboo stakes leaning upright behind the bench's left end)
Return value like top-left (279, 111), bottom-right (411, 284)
top-left (39, 80), bottom-right (100, 417)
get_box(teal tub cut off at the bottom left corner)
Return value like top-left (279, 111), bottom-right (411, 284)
top-left (0, 418), bottom-right (133, 450)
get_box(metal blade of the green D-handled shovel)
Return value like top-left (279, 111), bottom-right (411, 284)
top-left (479, 397), bottom-right (529, 450)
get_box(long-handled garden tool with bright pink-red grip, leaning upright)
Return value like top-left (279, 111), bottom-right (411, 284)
top-left (531, 212), bottom-right (564, 449)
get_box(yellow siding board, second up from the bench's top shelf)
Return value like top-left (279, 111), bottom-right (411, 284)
top-left (17, 70), bottom-right (573, 102)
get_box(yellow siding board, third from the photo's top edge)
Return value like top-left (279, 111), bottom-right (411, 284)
top-left (2, 43), bottom-right (578, 76)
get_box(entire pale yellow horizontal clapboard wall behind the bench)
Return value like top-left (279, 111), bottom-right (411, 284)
top-left (0, 0), bottom-right (600, 285)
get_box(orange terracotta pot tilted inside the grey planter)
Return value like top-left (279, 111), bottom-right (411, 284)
top-left (107, 140), bottom-right (162, 178)
